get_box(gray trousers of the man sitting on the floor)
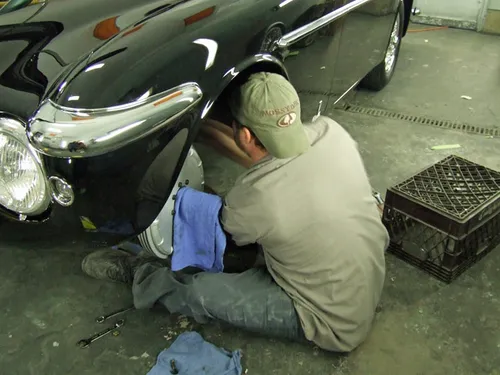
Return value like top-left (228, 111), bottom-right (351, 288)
top-left (132, 263), bottom-right (307, 342)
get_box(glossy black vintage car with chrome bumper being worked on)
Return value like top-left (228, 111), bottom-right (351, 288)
top-left (0, 0), bottom-right (412, 258)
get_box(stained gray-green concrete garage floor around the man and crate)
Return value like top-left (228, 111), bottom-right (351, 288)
top-left (0, 26), bottom-right (500, 375)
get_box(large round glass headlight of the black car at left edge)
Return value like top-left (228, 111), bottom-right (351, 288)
top-left (0, 118), bottom-right (50, 216)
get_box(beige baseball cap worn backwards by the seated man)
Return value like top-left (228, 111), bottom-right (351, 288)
top-left (230, 72), bottom-right (310, 159)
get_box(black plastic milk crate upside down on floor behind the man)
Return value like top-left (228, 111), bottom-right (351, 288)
top-left (383, 155), bottom-right (500, 283)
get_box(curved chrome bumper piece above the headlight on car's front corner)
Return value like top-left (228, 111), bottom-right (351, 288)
top-left (26, 82), bottom-right (203, 158)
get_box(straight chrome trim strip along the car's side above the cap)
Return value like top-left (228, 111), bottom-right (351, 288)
top-left (277, 0), bottom-right (372, 48)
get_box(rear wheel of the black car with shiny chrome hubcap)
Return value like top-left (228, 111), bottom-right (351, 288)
top-left (360, 7), bottom-right (403, 91)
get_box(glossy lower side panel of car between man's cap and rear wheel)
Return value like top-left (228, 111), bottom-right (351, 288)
top-left (285, 0), bottom-right (399, 117)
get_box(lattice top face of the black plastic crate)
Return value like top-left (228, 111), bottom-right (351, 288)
top-left (393, 155), bottom-right (500, 220)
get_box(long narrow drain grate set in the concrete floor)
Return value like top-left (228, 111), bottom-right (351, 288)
top-left (344, 104), bottom-right (500, 137)
